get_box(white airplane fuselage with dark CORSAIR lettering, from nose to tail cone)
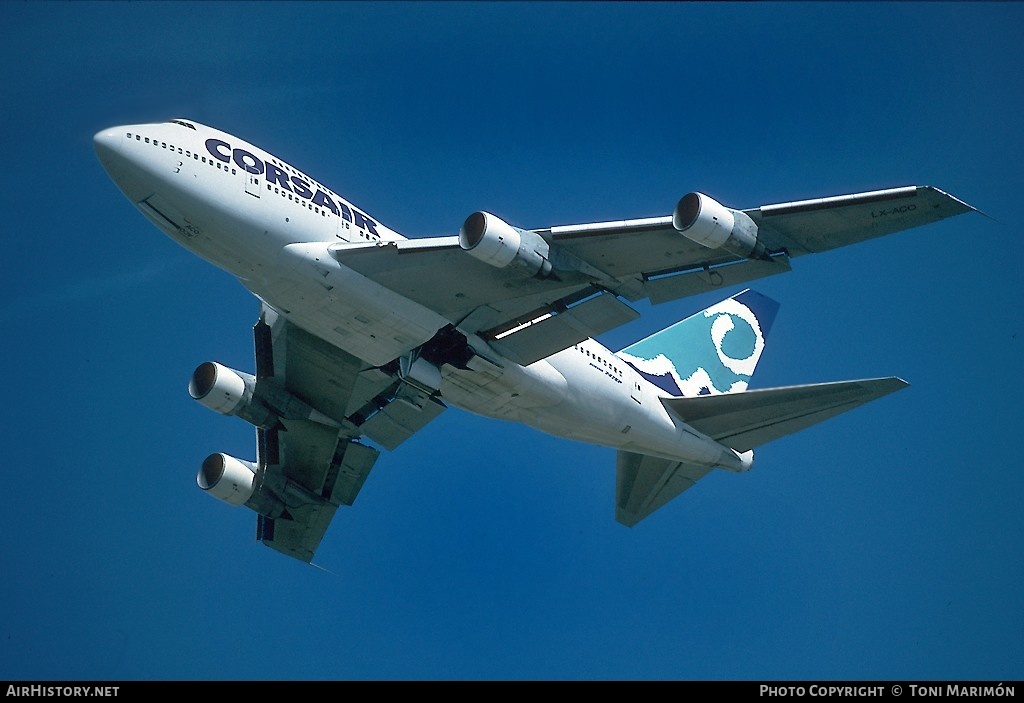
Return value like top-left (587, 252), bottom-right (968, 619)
top-left (95, 121), bottom-right (749, 470)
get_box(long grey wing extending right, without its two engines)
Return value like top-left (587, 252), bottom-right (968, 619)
top-left (331, 186), bottom-right (974, 364)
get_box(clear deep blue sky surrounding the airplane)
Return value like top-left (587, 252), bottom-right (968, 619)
top-left (0, 2), bottom-right (1024, 680)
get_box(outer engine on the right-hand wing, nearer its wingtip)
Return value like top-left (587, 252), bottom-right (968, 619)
top-left (672, 192), bottom-right (769, 259)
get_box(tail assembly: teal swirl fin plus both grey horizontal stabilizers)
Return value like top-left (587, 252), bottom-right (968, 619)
top-left (615, 291), bottom-right (906, 527)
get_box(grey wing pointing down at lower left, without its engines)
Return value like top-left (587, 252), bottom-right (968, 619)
top-left (248, 306), bottom-right (444, 562)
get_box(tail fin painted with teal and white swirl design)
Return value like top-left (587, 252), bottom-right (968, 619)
top-left (617, 291), bottom-right (778, 397)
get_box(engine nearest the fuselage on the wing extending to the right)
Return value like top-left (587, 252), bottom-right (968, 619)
top-left (459, 212), bottom-right (551, 278)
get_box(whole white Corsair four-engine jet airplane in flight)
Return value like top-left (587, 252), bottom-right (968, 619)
top-left (93, 119), bottom-right (977, 564)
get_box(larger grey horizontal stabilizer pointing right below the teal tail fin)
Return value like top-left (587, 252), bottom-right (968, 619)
top-left (662, 377), bottom-right (908, 452)
